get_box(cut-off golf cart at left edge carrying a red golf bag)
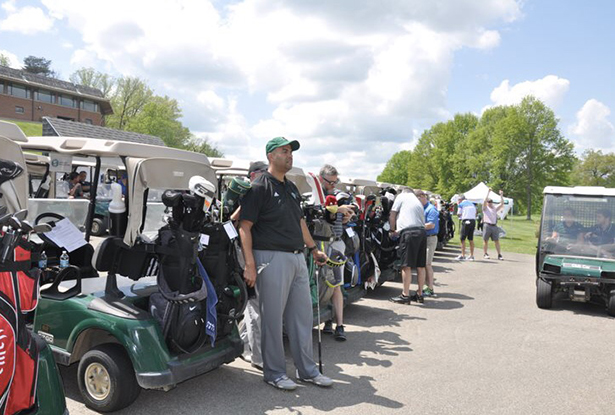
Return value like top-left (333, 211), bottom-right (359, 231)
top-left (0, 123), bottom-right (68, 415)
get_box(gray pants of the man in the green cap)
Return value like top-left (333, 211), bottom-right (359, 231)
top-left (254, 250), bottom-right (318, 381)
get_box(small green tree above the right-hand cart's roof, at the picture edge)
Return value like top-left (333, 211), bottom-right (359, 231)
top-left (571, 150), bottom-right (615, 187)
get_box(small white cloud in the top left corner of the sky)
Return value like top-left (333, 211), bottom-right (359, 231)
top-left (0, 0), bottom-right (53, 35)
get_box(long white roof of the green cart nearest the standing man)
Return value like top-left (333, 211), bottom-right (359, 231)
top-left (19, 137), bottom-right (209, 166)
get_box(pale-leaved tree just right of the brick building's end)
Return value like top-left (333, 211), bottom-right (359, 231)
top-left (106, 77), bottom-right (154, 134)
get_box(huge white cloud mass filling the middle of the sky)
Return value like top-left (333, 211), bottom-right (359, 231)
top-left (42, 0), bottom-right (521, 178)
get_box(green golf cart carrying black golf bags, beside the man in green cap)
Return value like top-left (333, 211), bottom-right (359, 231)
top-left (4, 123), bottom-right (247, 412)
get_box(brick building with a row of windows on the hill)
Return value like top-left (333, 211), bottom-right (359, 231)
top-left (0, 65), bottom-right (113, 125)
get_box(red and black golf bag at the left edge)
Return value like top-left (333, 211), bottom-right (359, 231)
top-left (0, 237), bottom-right (40, 415)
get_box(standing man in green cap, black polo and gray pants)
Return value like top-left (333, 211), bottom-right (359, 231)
top-left (239, 137), bottom-right (333, 390)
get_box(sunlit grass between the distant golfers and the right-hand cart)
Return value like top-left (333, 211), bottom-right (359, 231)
top-left (449, 215), bottom-right (540, 258)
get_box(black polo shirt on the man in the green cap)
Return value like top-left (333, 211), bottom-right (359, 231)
top-left (240, 172), bottom-right (305, 252)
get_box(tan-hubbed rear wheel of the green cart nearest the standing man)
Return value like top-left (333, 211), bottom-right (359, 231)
top-left (78, 344), bottom-right (141, 412)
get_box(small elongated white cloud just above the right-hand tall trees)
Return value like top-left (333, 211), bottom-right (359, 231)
top-left (491, 75), bottom-right (570, 108)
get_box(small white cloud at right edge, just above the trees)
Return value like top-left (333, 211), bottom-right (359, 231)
top-left (568, 98), bottom-right (615, 151)
